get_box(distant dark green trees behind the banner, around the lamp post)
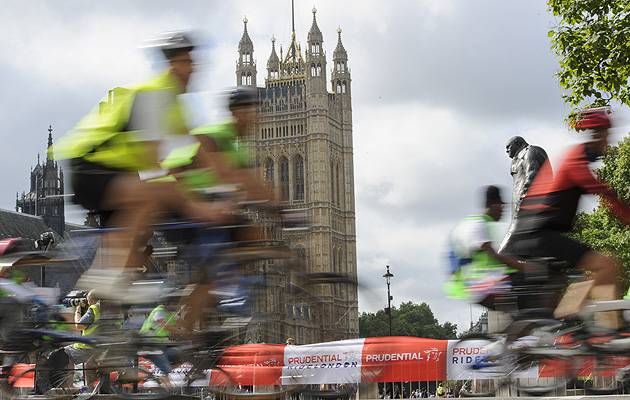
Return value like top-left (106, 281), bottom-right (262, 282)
top-left (359, 301), bottom-right (457, 339)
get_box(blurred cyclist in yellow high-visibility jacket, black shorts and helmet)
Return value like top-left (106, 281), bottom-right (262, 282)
top-left (53, 32), bottom-right (233, 287)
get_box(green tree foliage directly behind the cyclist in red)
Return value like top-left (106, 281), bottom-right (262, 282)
top-left (572, 137), bottom-right (630, 287)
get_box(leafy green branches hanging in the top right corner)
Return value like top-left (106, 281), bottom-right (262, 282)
top-left (548, 0), bottom-right (630, 107)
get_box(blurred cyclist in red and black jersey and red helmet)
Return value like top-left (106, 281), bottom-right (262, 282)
top-left (507, 108), bottom-right (630, 299)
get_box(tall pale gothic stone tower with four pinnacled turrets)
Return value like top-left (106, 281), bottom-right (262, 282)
top-left (236, 10), bottom-right (359, 344)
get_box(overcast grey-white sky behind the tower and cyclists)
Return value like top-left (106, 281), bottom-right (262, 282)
top-left (0, 0), bottom-right (627, 327)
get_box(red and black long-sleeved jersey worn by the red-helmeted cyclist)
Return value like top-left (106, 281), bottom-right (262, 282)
top-left (520, 144), bottom-right (630, 232)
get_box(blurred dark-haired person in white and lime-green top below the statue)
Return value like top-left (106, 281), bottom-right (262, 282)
top-left (445, 186), bottom-right (524, 308)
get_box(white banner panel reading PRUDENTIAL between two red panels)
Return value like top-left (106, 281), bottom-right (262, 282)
top-left (281, 339), bottom-right (364, 385)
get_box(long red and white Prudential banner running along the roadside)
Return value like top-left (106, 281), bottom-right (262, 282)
top-left (12, 336), bottom-right (630, 387)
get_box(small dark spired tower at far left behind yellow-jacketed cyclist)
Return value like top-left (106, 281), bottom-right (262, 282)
top-left (15, 126), bottom-right (65, 236)
